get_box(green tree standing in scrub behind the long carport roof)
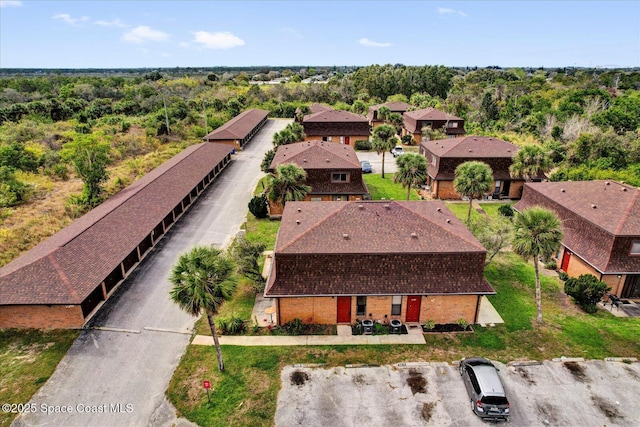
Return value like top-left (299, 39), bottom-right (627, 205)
top-left (61, 135), bottom-right (111, 207)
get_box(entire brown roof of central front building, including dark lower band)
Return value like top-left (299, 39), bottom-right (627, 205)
top-left (266, 201), bottom-right (494, 296)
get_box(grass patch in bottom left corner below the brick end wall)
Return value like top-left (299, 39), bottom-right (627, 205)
top-left (0, 329), bottom-right (80, 427)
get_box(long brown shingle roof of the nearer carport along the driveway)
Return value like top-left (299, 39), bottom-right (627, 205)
top-left (0, 143), bottom-right (230, 305)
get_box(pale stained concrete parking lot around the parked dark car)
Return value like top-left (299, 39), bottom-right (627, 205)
top-left (275, 361), bottom-right (640, 427)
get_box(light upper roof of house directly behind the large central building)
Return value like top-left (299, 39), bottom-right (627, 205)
top-left (269, 140), bottom-right (360, 169)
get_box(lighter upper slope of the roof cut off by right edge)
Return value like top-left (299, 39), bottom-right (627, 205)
top-left (516, 180), bottom-right (640, 236)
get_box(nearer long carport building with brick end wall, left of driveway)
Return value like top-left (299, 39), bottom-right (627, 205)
top-left (0, 143), bottom-right (231, 328)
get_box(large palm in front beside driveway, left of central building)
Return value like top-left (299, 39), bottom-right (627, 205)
top-left (169, 246), bottom-right (236, 372)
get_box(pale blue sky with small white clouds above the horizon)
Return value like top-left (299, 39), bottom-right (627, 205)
top-left (0, 0), bottom-right (640, 68)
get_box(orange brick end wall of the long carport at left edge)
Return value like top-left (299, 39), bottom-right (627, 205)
top-left (0, 305), bottom-right (84, 329)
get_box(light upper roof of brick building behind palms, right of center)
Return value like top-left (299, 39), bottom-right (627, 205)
top-left (420, 136), bottom-right (520, 158)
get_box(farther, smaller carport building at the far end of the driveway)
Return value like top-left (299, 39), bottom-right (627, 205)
top-left (202, 108), bottom-right (269, 150)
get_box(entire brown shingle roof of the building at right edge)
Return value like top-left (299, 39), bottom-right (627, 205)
top-left (514, 180), bottom-right (640, 272)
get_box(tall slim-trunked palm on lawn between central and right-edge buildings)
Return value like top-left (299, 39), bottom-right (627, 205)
top-left (511, 206), bottom-right (564, 323)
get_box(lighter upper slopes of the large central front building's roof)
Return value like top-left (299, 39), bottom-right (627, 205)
top-left (275, 201), bottom-right (486, 254)
